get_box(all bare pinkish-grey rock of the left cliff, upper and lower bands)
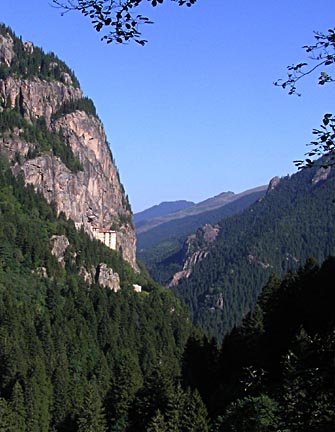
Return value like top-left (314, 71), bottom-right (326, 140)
top-left (0, 27), bottom-right (137, 270)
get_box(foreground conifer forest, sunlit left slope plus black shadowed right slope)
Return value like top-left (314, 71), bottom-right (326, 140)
top-left (0, 162), bottom-right (335, 432)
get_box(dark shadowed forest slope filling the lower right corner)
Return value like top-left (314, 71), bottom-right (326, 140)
top-left (183, 258), bottom-right (335, 432)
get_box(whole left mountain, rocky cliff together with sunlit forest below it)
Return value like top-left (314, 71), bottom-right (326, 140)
top-left (0, 25), bottom-right (207, 432)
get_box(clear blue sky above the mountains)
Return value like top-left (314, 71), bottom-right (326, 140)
top-left (0, 0), bottom-right (335, 212)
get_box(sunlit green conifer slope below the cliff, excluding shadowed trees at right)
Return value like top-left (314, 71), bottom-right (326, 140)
top-left (0, 136), bottom-right (207, 432)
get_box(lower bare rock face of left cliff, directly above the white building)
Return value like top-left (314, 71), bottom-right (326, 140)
top-left (10, 107), bottom-right (138, 270)
